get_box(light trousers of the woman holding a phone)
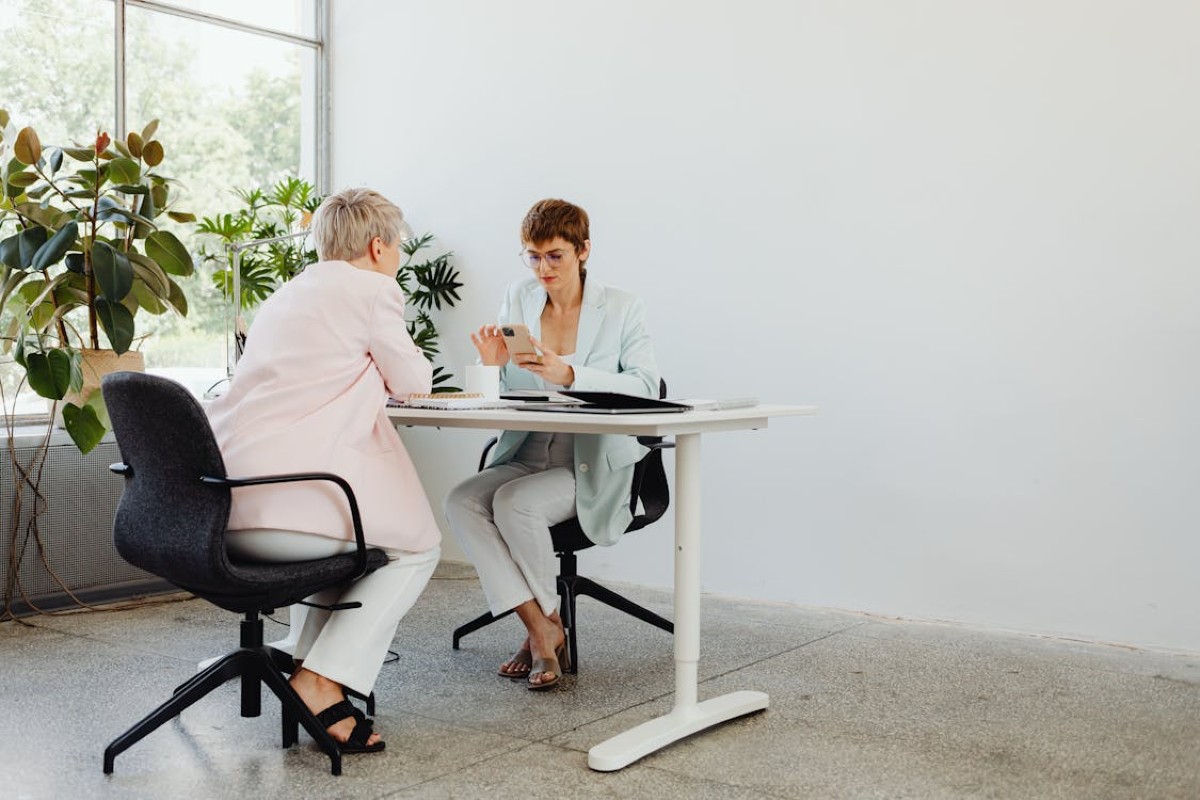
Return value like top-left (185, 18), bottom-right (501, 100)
top-left (445, 433), bottom-right (575, 616)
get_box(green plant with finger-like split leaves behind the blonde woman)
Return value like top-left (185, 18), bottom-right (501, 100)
top-left (198, 178), bottom-right (462, 392)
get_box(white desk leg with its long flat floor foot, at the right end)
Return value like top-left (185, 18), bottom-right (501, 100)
top-left (588, 433), bottom-right (767, 772)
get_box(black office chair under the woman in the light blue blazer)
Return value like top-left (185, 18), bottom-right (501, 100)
top-left (454, 380), bottom-right (674, 673)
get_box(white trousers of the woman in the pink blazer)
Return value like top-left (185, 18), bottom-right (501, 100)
top-left (226, 528), bottom-right (442, 694)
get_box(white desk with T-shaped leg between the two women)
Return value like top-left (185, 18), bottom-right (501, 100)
top-left (388, 405), bottom-right (817, 772)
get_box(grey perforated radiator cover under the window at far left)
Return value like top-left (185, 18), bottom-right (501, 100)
top-left (0, 433), bottom-right (172, 615)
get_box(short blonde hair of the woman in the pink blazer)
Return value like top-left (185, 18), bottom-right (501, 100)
top-left (312, 188), bottom-right (404, 261)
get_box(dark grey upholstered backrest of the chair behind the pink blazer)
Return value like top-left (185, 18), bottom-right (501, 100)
top-left (102, 372), bottom-right (230, 591)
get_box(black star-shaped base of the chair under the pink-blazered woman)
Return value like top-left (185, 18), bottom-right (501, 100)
top-left (104, 612), bottom-right (342, 775)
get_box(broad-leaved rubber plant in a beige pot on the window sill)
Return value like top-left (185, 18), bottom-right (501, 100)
top-left (0, 109), bottom-right (194, 452)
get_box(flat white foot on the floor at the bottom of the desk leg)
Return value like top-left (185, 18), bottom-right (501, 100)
top-left (588, 691), bottom-right (768, 772)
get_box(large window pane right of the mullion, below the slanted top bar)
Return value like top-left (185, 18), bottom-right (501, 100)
top-left (126, 2), bottom-right (316, 381)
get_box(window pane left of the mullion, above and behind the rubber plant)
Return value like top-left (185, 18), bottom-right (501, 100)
top-left (0, 0), bottom-right (115, 414)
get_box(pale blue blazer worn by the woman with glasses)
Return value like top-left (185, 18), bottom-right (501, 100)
top-left (492, 277), bottom-right (659, 545)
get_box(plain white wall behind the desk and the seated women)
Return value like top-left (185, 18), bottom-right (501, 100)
top-left (332, 0), bottom-right (1200, 650)
